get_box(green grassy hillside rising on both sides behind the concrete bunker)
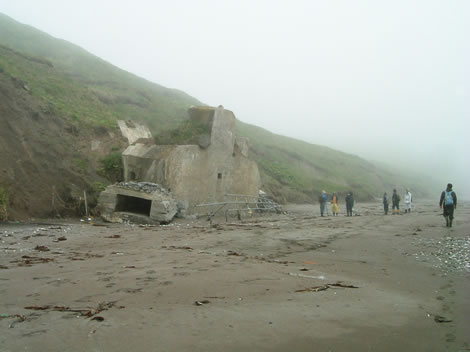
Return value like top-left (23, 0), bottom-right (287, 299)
top-left (0, 14), bottom-right (434, 206)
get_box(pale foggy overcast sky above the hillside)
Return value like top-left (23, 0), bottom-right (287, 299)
top-left (0, 0), bottom-right (470, 192)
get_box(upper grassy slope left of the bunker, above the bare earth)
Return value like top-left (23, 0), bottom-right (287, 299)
top-left (0, 14), bottom-right (200, 130)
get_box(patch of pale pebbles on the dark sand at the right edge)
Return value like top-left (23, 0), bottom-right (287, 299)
top-left (414, 236), bottom-right (470, 273)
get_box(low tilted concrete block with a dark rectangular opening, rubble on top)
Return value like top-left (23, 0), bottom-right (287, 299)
top-left (98, 182), bottom-right (177, 224)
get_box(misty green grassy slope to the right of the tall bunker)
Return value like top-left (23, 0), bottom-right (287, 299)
top-left (238, 124), bottom-right (432, 200)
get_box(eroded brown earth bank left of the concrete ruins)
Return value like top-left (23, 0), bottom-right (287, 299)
top-left (0, 72), bottom-right (122, 219)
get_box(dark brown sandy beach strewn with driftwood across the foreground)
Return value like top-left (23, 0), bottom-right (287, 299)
top-left (0, 202), bottom-right (470, 352)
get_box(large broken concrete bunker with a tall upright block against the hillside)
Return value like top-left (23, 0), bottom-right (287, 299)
top-left (119, 106), bottom-right (260, 214)
